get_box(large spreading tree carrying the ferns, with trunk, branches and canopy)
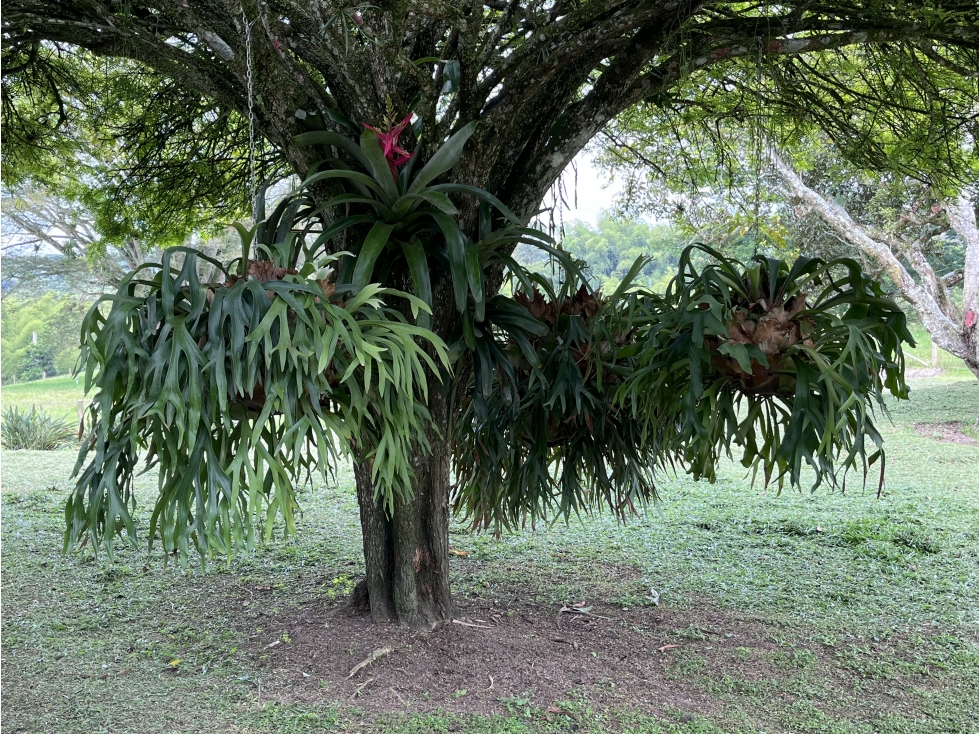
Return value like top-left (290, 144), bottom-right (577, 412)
top-left (3, 0), bottom-right (979, 626)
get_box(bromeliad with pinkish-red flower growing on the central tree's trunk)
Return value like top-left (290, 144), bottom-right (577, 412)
top-left (297, 118), bottom-right (549, 328)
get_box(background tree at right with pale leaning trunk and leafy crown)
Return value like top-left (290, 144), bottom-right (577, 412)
top-left (604, 103), bottom-right (979, 374)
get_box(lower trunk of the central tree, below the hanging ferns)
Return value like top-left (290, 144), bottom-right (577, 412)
top-left (352, 379), bottom-right (452, 630)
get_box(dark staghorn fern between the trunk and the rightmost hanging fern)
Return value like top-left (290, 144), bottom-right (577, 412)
top-left (453, 256), bottom-right (661, 531)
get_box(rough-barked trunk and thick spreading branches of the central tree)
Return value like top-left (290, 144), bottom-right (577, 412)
top-left (4, 0), bottom-right (979, 627)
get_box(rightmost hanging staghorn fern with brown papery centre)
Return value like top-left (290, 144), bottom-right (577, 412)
top-left (617, 246), bottom-right (914, 494)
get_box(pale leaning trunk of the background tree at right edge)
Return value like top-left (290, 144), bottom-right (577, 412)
top-left (769, 150), bottom-right (979, 378)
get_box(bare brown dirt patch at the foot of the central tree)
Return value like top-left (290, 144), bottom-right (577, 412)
top-left (243, 600), bottom-right (812, 728)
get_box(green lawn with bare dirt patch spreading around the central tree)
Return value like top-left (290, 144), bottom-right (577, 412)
top-left (0, 374), bottom-right (979, 734)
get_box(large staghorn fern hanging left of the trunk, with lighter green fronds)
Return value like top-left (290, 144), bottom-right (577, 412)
top-left (65, 244), bottom-right (447, 563)
